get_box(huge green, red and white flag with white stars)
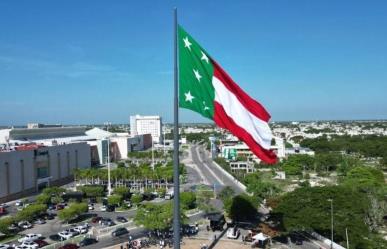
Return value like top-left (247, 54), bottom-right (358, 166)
top-left (178, 26), bottom-right (277, 164)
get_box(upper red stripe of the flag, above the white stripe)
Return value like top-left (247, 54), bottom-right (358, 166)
top-left (211, 60), bottom-right (270, 122)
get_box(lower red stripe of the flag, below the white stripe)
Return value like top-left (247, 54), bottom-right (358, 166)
top-left (214, 101), bottom-right (277, 164)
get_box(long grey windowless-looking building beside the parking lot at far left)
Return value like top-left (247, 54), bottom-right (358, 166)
top-left (0, 143), bottom-right (90, 202)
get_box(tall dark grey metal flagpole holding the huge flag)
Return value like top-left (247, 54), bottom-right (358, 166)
top-left (173, 8), bottom-right (180, 249)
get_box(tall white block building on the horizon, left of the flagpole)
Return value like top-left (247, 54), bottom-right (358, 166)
top-left (130, 115), bottom-right (163, 143)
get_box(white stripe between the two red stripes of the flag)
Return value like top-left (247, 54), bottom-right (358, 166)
top-left (212, 77), bottom-right (272, 150)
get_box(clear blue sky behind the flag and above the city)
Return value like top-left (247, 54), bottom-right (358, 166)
top-left (0, 0), bottom-right (387, 125)
